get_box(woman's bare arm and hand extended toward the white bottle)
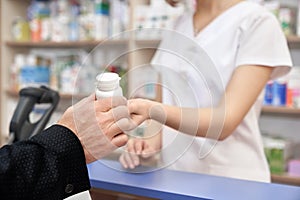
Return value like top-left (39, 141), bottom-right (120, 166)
top-left (129, 65), bottom-right (272, 140)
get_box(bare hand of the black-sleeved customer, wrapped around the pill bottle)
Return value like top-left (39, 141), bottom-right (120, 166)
top-left (58, 94), bottom-right (132, 163)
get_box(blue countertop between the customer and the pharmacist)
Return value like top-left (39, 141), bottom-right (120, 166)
top-left (88, 160), bottom-right (300, 200)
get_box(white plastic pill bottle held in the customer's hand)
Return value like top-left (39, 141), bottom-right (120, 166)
top-left (95, 72), bottom-right (123, 99)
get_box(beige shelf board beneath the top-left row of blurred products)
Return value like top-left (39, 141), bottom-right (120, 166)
top-left (5, 39), bottom-right (128, 48)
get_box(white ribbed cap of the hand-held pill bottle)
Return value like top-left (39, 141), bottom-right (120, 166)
top-left (96, 72), bottom-right (121, 91)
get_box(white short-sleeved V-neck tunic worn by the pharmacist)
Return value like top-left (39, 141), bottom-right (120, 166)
top-left (152, 1), bottom-right (292, 182)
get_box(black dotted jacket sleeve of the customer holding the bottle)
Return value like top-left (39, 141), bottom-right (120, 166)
top-left (0, 125), bottom-right (90, 200)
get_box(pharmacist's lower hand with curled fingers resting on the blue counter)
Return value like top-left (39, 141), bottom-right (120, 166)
top-left (119, 138), bottom-right (156, 169)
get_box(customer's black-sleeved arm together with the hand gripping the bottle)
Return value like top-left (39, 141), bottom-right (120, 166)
top-left (0, 94), bottom-right (129, 200)
